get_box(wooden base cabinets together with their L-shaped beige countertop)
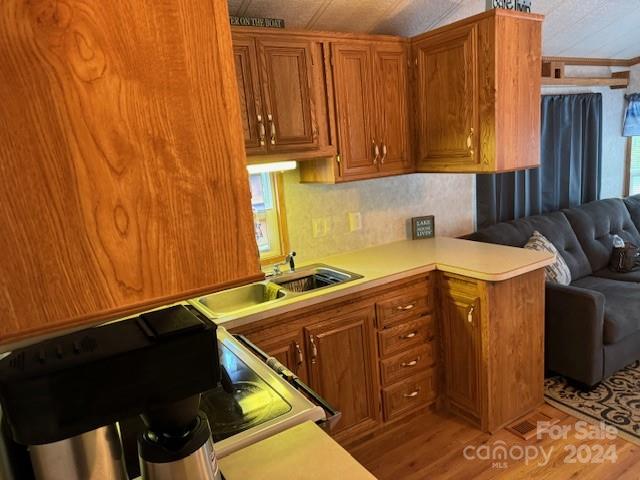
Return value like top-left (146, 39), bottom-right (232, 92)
top-left (191, 237), bottom-right (554, 445)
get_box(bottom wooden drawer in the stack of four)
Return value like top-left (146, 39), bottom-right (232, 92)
top-left (382, 368), bottom-right (438, 421)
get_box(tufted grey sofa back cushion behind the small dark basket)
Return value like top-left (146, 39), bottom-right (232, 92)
top-left (563, 198), bottom-right (640, 278)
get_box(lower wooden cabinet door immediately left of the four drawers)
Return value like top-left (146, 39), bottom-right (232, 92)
top-left (305, 306), bottom-right (380, 439)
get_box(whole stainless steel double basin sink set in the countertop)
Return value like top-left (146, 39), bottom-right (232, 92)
top-left (197, 264), bottom-right (362, 318)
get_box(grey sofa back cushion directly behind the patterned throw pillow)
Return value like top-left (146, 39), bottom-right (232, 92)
top-left (466, 212), bottom-right (591, 279)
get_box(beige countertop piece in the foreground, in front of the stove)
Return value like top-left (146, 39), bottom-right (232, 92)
top-left (219, 422), bottom-right (375, 480)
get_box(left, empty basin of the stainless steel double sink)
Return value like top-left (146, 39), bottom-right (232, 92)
top-left (198, 283), bottom-right (288, 318)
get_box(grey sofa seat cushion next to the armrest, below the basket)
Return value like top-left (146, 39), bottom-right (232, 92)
top-left (571, 275), bottom-right (640, 345)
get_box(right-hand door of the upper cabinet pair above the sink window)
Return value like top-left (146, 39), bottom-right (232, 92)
top-left (258, 37), bottom-right (318, 153)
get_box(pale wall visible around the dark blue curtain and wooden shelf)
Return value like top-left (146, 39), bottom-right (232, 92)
top-left (542, 67), bottom-right (627, 198)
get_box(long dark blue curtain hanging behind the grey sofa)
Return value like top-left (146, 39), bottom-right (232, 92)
top-left (476, 93), bottom-right (602, 229)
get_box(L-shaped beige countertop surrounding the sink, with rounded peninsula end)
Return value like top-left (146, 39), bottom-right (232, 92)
top-left (191, 237), bottom-right (554, 328)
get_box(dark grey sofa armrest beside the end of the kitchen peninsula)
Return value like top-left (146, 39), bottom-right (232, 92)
top-left (545, 283), bottom-right (605, 386)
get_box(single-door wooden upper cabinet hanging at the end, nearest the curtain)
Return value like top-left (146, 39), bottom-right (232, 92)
top-left (411, 9), bottom-right (543, 173)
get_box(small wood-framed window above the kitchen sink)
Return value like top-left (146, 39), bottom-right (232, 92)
top-left (249, 173), bottom-right (289, 265)
